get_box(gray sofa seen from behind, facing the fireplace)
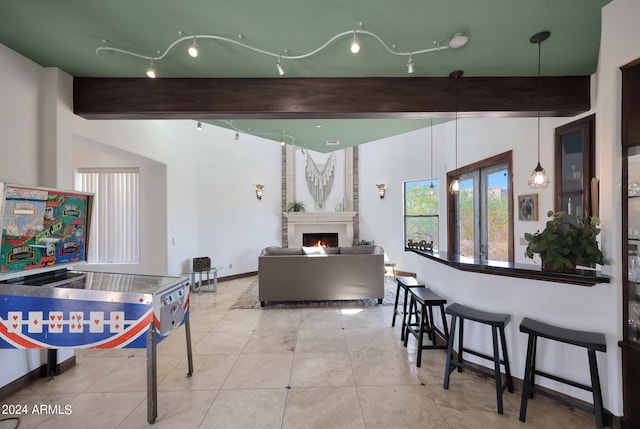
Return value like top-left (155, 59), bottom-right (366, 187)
top-left (258, 246), bottom-right (384, 306)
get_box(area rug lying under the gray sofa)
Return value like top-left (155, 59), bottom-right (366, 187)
top-left (229, 276), bottom-right (397, 310)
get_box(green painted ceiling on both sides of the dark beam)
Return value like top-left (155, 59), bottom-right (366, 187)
top-left (0, 0), bottom-right (611, 151)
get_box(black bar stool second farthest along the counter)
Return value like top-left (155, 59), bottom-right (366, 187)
top-left (404, 287), bottom-right (449, 367)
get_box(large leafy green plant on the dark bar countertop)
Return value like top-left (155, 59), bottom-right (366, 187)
top-left (524, 211), bottom-right (606, 272)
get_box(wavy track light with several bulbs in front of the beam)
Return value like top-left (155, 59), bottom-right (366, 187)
top-left (96, 23), bottom-right (469, 77)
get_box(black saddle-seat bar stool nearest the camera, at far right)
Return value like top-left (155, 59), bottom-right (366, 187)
top-left (520, 317), bottom-right (607, 429)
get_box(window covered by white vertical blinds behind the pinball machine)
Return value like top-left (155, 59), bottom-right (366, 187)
top-left (75, 168), bottom-right (140, 264)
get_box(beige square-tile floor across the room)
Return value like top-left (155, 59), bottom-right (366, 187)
top-left (0, 278), bottom-right (595, 429)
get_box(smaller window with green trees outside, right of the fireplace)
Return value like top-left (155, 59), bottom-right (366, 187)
top-left (404, 179), bottom-right (440, 249)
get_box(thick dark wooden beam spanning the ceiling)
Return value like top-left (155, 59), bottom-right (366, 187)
top-left (73, 76), bottom-right (591, 119)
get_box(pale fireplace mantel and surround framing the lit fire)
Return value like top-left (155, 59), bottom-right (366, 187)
top-left (283, 211), bottom-right (358, 247)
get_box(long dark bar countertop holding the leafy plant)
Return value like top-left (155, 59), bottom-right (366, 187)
top-left (405, 248), bottom-right (610, 286)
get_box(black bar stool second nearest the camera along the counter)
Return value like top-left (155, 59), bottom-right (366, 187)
top-left (444, 303), bottom-right (513, 414)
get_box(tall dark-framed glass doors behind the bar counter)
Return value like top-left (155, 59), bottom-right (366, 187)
top-left (447, 152), bottom-right (513, 261)
